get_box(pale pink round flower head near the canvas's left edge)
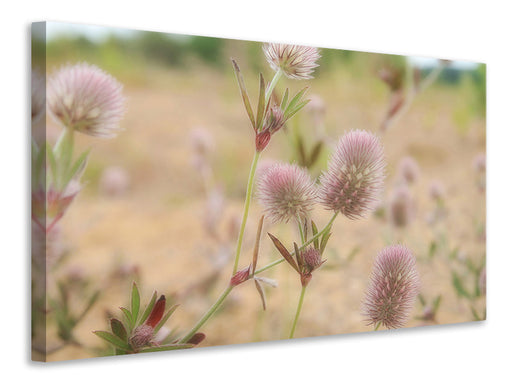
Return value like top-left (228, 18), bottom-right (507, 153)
top-left (47, 63), bottom-right (124, 137)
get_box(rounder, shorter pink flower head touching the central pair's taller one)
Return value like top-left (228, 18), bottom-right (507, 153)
top-left (258, 163), bottom-right (316, 223)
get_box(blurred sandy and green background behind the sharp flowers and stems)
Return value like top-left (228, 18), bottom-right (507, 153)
top-left (33, 23), bottom-right (486, 360)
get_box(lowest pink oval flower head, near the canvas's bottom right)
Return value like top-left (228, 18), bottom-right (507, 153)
top-left (363, 245), bottom-right (420, 328)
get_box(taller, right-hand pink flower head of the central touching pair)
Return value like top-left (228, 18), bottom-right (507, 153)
top-left (319, 130), bottom-right (385, 219)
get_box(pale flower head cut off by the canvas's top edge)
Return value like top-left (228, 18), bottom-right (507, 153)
top-left (263, 43), bottom-right (320, 80)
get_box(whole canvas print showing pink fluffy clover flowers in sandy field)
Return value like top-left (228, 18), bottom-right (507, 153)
top-left (31, 22), bottom-right (486, 361)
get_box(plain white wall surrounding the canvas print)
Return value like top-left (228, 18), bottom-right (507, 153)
top-left (0, 0), bottom-right (512, 383)
